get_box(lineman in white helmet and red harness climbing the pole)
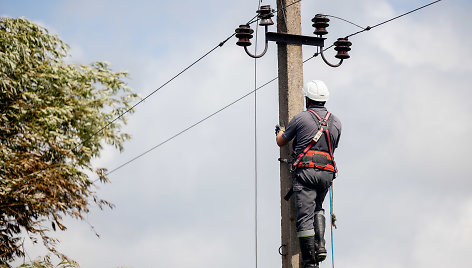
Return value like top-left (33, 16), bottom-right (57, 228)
top-left (276, 80), bottom-right (341, 268)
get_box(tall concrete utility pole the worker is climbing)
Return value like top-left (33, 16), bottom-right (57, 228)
top-left (277, 0), bottom-right (304, 268)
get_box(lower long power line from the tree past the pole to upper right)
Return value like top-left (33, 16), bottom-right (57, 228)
top-left (106, 0), bottom-right (442, 175)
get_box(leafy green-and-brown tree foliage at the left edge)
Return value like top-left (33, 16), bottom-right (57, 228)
top-left (0, 18), bottom-right (136, 264)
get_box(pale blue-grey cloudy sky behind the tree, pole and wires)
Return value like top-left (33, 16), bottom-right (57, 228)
top-left (0, 0), bottom-right (472, 268)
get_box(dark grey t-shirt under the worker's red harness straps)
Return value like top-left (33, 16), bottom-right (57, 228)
top-left (282, 106), bottom-right (341, 155)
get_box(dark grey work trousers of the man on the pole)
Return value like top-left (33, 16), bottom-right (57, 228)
top-left (293, 168), bottom-right (334, 237)
